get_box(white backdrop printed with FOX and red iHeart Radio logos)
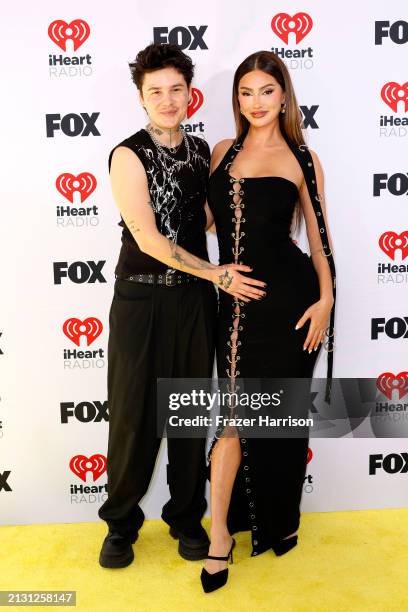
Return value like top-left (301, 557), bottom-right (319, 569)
top-left (0, 0), bottom-right (408, 524)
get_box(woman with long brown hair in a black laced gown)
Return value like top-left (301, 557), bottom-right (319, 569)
top-left (201, 51), bottom-right (335, 592)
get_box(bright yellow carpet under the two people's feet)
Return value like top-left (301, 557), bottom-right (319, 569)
top-left (0, 509), bottom-right (408, 612)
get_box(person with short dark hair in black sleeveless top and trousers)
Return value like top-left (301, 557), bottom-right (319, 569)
top-left (99, 44), bottom-right (263, 568)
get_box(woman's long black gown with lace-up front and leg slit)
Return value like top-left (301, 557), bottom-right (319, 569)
top-left (208, 141), bottom-right (320, 556)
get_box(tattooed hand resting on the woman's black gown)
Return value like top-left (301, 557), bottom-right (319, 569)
top-left (211, 264), bottom-right (266, 302)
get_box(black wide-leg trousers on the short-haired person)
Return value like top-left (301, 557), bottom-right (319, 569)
top-left (99, 279), bottom-right (217, 540)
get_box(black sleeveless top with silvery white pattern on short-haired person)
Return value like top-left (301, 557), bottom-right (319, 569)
top-left (109, 129), bottom-right (210, 276)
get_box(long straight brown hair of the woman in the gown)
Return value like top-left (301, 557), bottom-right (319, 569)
top-left (232, 51), bottom-right (305, 228)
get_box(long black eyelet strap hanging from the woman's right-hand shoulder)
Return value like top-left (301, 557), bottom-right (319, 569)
top-left (288, 142), bottom-right (336, 403)
